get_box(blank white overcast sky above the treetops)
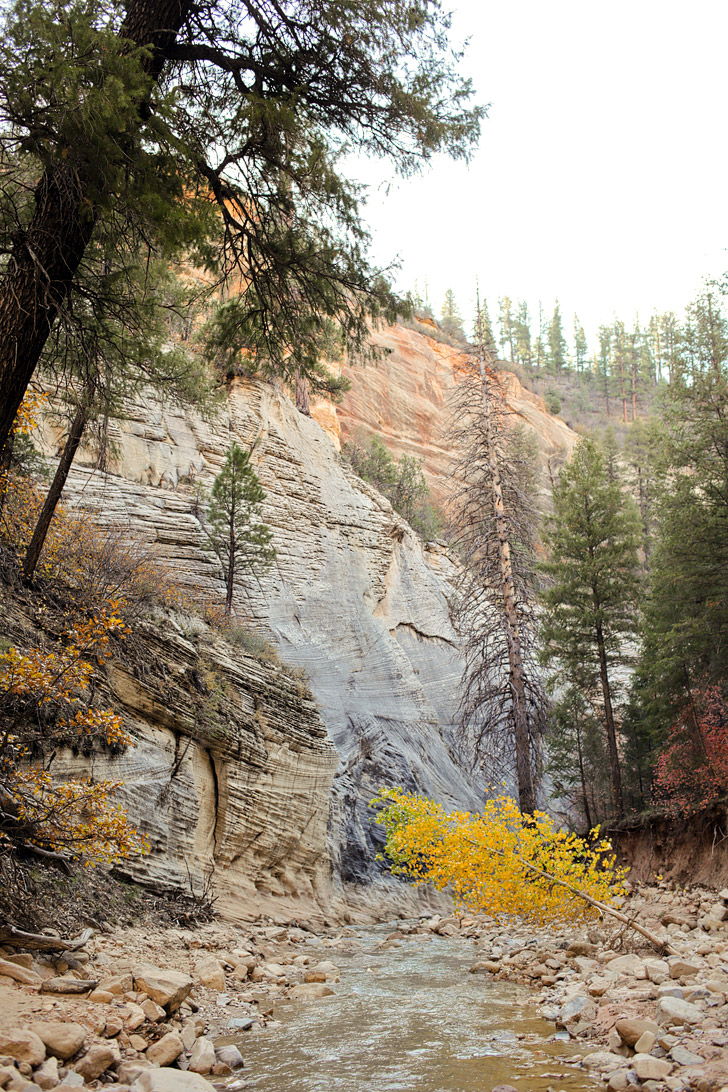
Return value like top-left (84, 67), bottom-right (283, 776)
top-left (349, 0), bottom-right (728, 349)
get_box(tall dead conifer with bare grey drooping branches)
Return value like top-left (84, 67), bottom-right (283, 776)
top-left (452, 294), bottom-right (545, 814)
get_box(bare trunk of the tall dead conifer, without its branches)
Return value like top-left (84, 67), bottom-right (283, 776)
top-left (478, 308), bottom-right (536, 815)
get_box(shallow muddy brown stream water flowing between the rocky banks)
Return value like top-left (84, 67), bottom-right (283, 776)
top-left (234, 926), bottom-right (602, 1092)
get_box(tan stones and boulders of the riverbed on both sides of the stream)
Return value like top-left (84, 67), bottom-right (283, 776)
top-left (0, 885), bottom-right (728, 1092)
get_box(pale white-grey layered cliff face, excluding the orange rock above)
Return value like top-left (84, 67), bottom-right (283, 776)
top-left (48, 380), bottom-right (482, 912)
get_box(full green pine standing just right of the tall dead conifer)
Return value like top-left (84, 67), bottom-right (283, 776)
top-left (542, 439), bottom-right (640, 815)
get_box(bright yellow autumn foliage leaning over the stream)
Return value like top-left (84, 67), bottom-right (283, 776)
top-left (371, 788), bottom-right (625, 925)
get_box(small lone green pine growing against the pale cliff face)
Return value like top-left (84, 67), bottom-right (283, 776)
top-left (205, 443), bottom-right (275, 615)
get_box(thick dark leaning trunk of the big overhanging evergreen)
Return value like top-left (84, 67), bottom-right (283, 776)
top-left (0, 0), bottom-right (192, 451)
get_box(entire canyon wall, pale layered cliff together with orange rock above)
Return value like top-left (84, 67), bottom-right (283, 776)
top-left (35, 318), bottom-right (573, 918)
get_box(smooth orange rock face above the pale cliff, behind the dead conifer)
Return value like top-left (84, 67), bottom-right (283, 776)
top-left (311, 325), bottom-right (576, 502)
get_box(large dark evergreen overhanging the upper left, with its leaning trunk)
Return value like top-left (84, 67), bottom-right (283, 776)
top-left (0, 0), bottom-right (484, 452)
